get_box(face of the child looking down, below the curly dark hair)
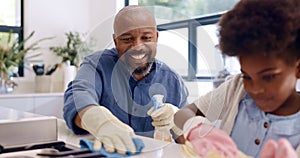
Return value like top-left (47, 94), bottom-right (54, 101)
top-left (239, 55), bottom-right (300, 115)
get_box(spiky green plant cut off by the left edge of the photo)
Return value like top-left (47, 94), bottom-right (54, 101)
top-left (0, 31), bottom-right (50, 93)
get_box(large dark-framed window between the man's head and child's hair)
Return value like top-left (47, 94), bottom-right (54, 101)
top-left (125, 0), bottom-right (239, 80)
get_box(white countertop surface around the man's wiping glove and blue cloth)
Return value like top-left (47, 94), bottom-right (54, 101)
top-left (58, 120), bottom-right (183, 158)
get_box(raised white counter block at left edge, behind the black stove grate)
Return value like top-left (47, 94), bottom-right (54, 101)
top-left (0, 107), bottom-right (58, 147)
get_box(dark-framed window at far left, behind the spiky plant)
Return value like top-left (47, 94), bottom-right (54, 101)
top-left (0, 0), bottom-right (23, 76)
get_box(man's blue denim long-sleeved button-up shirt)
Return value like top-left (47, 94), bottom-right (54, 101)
top-left (63, 48), bottom-right (188, 137)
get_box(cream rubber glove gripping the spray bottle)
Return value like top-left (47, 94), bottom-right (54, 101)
top-left (147, 103), bottom-right (182, 136)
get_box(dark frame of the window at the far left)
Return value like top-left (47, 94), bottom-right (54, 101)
top-left (0, 0), bottom-right (24, 77)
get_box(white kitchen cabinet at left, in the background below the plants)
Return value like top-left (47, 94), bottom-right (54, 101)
top-left (0, 93), bottom-right (63, 118)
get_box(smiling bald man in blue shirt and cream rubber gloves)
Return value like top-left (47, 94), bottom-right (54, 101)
top-left (64, 6), bottom-right (188, 154)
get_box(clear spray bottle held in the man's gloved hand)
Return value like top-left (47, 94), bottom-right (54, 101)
top-left (152, 94), bottom-right (172, 142)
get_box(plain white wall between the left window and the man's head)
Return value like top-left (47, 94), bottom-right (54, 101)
top-left (24, 0), bottom-right (118, 78)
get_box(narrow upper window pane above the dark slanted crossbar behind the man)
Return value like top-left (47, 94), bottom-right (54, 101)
top-left (137, 0), bottom-right (237, 22)
